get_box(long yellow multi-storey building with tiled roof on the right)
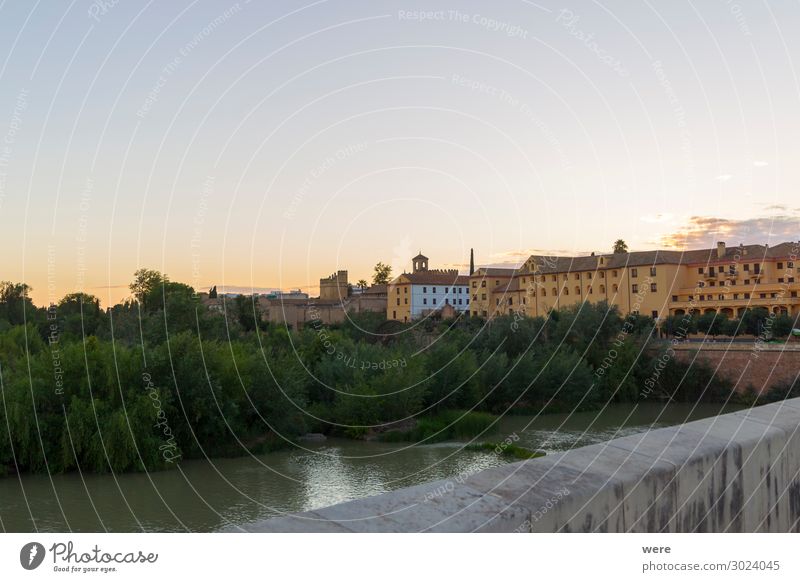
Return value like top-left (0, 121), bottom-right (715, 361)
top-left (469, 242), bottom-right (800, 319)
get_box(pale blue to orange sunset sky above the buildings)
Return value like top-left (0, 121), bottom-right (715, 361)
top-left (0, 0), bottom-right (800, 305)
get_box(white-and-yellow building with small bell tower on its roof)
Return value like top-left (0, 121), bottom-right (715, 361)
top-left (386, 253), bottom-right (470, 321)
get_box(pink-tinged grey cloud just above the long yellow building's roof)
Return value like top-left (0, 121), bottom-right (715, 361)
top-left (659, 214), bottom-right (800, 249)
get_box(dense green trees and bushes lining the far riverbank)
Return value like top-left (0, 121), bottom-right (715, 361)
top-left (0, 271), bottom-right (789, 480)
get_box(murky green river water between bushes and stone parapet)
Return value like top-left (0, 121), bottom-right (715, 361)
top-left (0, 403), bottom-right (736, 532)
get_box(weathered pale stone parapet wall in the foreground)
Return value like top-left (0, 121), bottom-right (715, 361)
top-left (235, 398), bottom-right (800, 532)
